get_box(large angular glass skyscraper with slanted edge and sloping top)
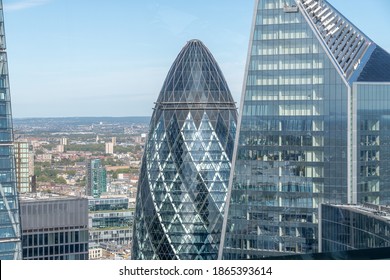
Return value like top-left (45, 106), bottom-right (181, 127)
top-left (219, 0), bottom-right (390, 259)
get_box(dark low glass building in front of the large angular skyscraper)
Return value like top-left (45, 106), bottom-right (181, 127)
top-left (319, 203), bottom-right (390, 252)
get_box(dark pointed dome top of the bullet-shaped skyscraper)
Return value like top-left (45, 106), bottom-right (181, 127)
top-left (156, 39), bottom-right (234, 109)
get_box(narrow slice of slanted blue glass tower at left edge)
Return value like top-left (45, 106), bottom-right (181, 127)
top-left (0, 0), bottom-right (21, 260)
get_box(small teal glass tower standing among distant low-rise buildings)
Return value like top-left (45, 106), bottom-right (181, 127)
top-left (86, 159), bottom-right (107, 197)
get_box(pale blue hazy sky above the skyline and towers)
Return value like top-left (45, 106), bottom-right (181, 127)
top-left (3, 0), bottom-right (390, 117)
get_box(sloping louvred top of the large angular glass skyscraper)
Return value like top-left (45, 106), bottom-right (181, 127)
top-left (296, 0), bottom-right (390, 84)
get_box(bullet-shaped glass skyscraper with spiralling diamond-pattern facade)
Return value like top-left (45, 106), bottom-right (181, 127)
top-left (133, 40), bottom-right (237, 260)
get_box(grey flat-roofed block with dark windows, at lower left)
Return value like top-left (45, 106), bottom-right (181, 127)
top-left (20, 193), bottom-right (88, 260)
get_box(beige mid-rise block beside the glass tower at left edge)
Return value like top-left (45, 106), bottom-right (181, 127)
top-left (14, 141), bottom-right (34, 193)
